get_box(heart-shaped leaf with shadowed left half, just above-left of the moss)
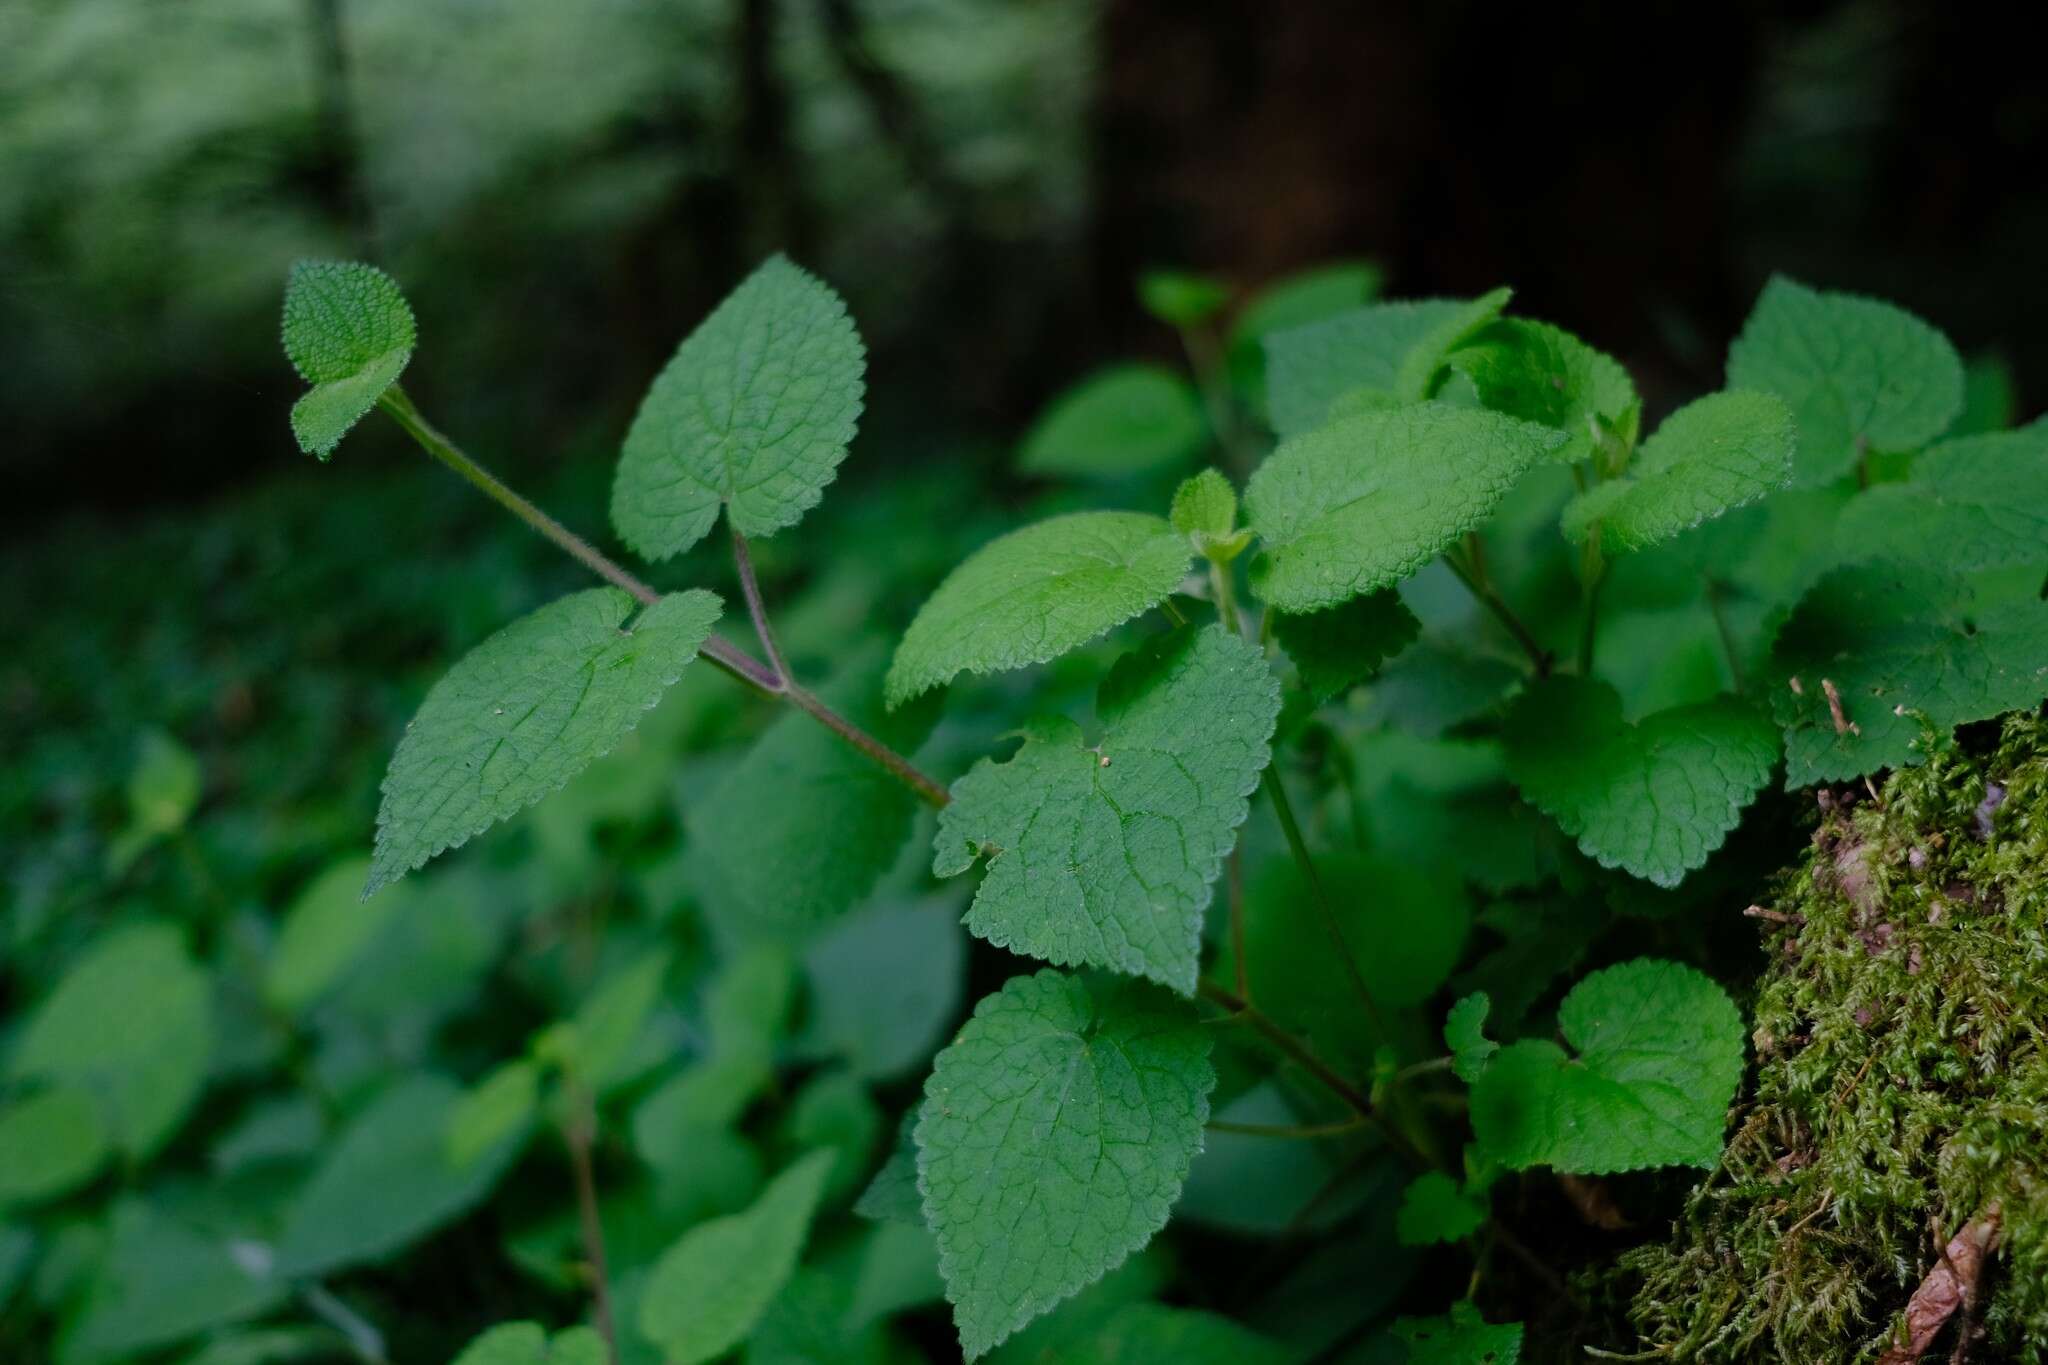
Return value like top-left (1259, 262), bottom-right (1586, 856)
top-left (1503, 677), bottom-right (1778, 886)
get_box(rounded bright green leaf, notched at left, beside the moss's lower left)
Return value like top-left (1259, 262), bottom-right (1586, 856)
top-left (1473, 958), bottom-right (1743, 1175)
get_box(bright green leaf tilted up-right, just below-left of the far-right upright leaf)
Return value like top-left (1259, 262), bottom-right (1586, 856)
top-left (1565, 393), bottom-right (1794, 555)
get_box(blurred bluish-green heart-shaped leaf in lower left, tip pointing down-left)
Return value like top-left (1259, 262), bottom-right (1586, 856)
top-left (274, 1074), bottom-right (518, 1279)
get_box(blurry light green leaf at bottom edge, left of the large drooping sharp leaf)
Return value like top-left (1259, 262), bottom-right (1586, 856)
top-left (639, 1152), bottom-right (831, 1365)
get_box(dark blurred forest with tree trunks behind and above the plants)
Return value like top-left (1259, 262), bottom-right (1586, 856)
top-left (0, 0), bottom-right (2048, 523)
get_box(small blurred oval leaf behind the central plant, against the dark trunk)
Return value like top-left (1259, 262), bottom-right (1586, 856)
top-left (1018, 364), bottom-right (1208, 479)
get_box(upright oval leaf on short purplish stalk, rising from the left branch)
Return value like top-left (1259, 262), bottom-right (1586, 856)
top-left (612, 256), bottom-right (866, 559)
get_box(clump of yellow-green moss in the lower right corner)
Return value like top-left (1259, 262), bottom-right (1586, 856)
top-left (1622, 716), bottom-right (2048, 1365)
